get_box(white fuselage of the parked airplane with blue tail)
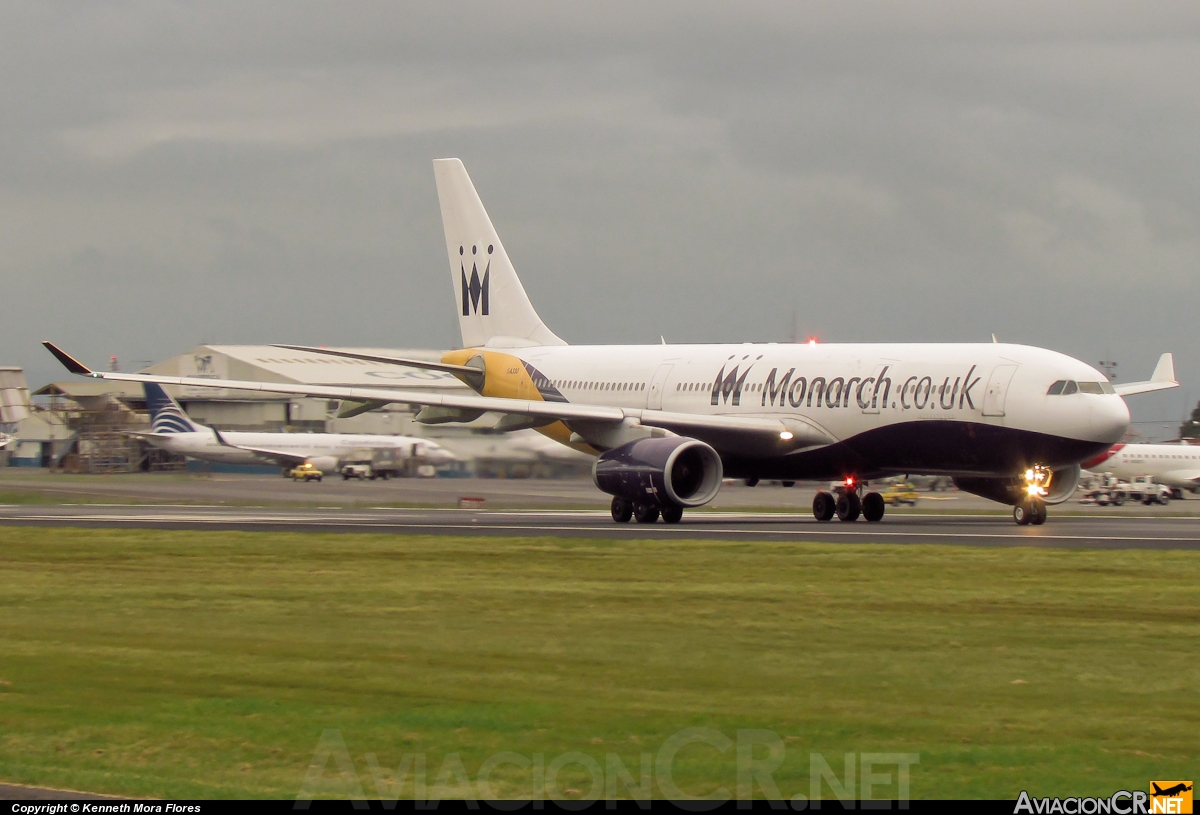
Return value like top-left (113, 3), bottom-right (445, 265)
top-left (148, 427), bottom-right (451, 465)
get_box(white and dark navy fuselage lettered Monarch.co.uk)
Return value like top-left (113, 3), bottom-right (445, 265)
top-left (504, 343), bottom-right (1129, 478)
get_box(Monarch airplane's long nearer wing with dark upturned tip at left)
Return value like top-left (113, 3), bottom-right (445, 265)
top-left (42, 342), bottom-right (835, 449)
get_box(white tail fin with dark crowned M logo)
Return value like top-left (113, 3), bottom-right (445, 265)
top-left (433, 158), bottom-right (566, 348)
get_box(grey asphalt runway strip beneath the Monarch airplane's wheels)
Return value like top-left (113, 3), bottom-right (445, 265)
top-left (0, 504), bottom-right (1200, 550)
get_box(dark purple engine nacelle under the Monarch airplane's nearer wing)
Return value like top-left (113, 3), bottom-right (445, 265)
top-left (592, 436), bottom-right (725, 507)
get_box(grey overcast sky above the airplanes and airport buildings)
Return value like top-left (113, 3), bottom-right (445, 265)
top-left (0, 0), bottom-right (1200, 434)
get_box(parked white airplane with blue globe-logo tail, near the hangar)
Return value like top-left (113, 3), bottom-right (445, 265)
top-left (132, 382), bottom-right (456, 473)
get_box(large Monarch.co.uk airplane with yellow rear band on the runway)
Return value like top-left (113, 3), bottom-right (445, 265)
top-left (44, 158), bottom-right (1178, 525)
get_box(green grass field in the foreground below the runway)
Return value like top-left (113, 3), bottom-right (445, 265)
top-left (0, 527), bottom-right (1200, 797)
